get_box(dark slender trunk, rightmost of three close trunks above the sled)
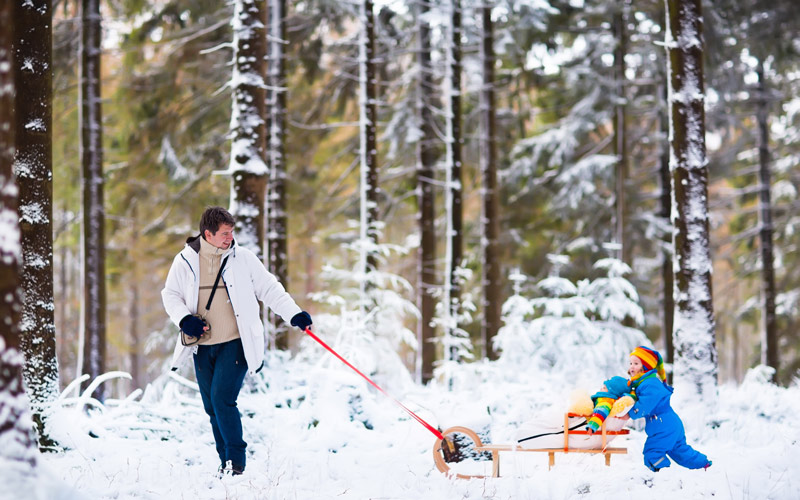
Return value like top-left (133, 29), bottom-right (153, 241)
top-left (480, 2), bottom-right (502, 359)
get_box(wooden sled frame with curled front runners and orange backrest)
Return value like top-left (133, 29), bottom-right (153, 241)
top-left (433, 413), bottom-right (630, 479)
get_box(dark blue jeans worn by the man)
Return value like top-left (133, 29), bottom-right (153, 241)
top-left (194, 339), bottom-right (247, 470)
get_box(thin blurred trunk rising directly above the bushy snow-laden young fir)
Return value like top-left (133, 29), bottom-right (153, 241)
top-left (614, 0), bottom-right (631, 264)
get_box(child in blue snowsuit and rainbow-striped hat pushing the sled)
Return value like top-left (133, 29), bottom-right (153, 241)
top-left (628, 346), bottom-right (711, 472)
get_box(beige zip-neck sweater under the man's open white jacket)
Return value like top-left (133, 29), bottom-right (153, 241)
top-left (197, 238), bottom-right (239, 345)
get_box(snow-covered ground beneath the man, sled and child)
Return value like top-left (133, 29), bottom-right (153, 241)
top-left (6, 352), bottom-right (800, 500)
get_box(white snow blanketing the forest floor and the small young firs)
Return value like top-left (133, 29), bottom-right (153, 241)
top-left (6, 264), bottom-right (800, 500)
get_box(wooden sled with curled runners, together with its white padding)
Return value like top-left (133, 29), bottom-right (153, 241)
top-left (433, 413), bottom-right (630, 479)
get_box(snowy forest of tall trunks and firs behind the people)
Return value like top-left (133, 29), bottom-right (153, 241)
top-left (0, 0), bottom-right (800, 494)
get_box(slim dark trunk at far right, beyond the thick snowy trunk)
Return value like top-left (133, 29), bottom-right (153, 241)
top-left (756, 60), bottom-right (779, 382)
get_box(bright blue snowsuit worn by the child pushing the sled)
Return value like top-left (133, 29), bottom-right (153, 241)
top-left (628, 374), bottom-right (709, 470)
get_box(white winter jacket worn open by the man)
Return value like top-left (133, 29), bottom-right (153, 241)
top-left (161, 236), bottom-right (301, 374)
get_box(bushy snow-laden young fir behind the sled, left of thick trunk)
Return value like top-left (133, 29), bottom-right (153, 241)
top-left (496, 256), bottom-right (647, 378)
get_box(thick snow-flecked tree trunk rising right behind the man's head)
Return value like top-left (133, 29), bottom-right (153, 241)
top-left (228, 0), bottom-right (268, 258)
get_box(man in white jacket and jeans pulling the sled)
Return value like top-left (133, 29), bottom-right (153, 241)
top-left (161, 207), bottom-right (311, 475)
